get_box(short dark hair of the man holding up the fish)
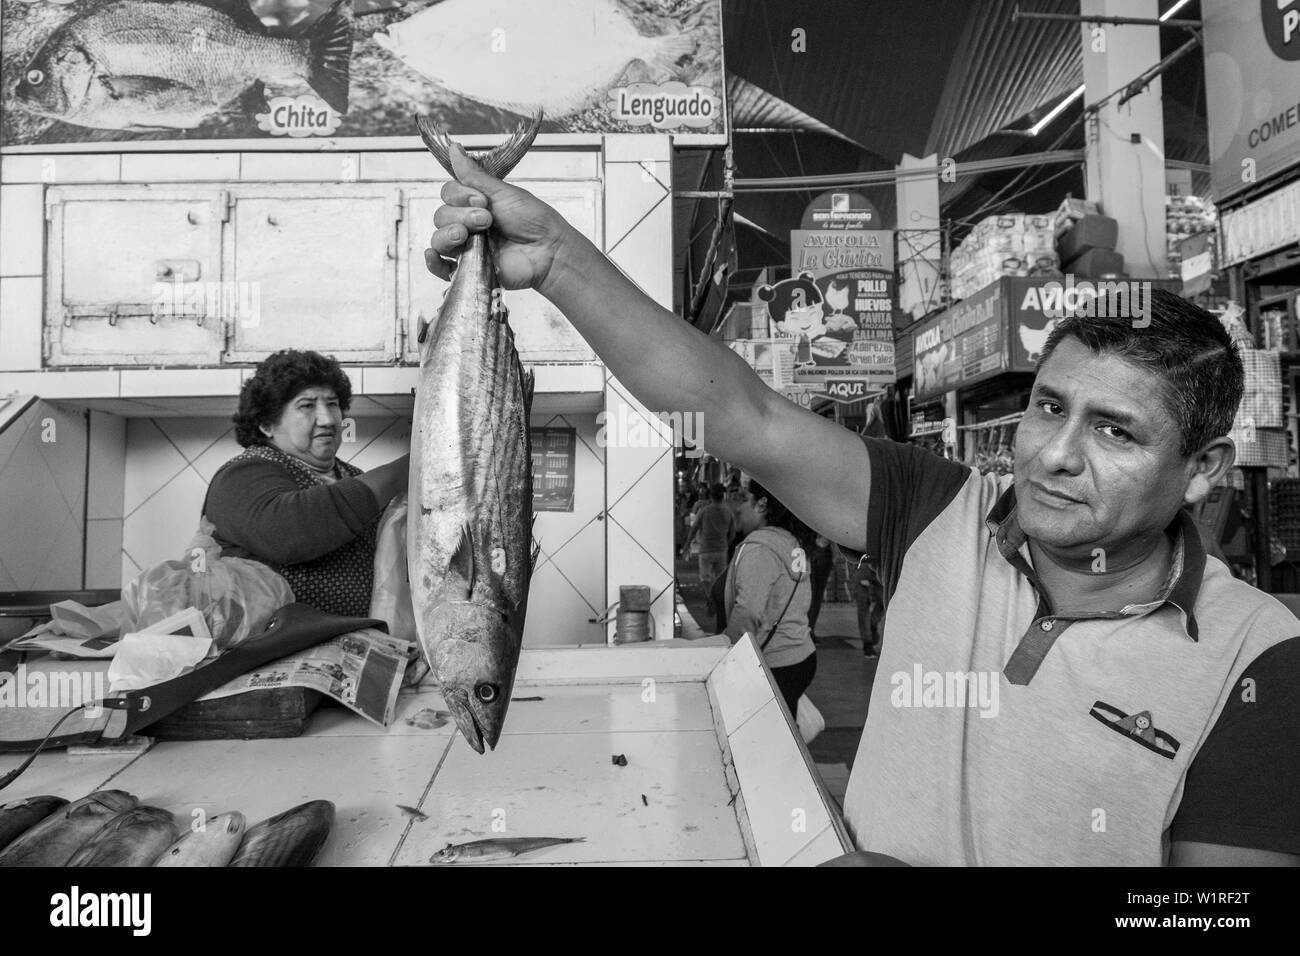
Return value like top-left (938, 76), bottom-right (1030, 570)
top-left (1039, 289), bottom-right (1245, 458)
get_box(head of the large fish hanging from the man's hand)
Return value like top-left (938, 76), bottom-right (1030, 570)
top-left (421, 601), bottom-right (523, 753)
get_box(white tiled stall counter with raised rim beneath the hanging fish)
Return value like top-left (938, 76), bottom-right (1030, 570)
top-left (0, 641), bottom-right (850, 866)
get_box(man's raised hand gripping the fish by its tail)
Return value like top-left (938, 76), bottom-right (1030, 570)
top-left (424, 144), bottom-right (577, 290)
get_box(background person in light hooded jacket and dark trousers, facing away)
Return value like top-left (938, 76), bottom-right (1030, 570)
top-left (724, 479), bottom-right (816, 717)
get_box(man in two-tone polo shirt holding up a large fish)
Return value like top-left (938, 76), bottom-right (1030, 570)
top-left (425, 147), bottom-right (1300, 865)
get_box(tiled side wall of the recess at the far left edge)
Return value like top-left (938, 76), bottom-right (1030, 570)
top-left (0, 402), bottom-right (86, 591)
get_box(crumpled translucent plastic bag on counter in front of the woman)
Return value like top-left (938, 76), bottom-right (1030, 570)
top-left (122, 518), bottom-right (294, 650)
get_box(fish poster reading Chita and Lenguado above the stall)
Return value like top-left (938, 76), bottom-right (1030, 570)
top-left (0, 0), bottom-right (727, 152)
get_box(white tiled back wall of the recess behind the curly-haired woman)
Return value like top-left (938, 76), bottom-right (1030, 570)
top-left (119, 415), bottom-right (605, 646)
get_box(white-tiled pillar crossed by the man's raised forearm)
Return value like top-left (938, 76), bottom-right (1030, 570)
top-left (603, 134), bottom-right (676, 640)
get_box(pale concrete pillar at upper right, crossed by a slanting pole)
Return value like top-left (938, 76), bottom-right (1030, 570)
top-left (1079, 0), bottom-right (1169, 278)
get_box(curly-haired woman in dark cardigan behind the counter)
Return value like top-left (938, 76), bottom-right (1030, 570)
top-left (203, 350), bottom-right (411, 618)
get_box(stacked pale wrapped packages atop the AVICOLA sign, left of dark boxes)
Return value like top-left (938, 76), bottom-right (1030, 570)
top-left (952, 212), bottom-right (1060, 299)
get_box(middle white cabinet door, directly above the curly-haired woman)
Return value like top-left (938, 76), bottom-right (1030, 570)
top-left (225, 183), bottom-right (398, 362)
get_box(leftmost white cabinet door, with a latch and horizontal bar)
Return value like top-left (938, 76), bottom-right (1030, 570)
top-left (46, 185), bottom-right (230, 365)
